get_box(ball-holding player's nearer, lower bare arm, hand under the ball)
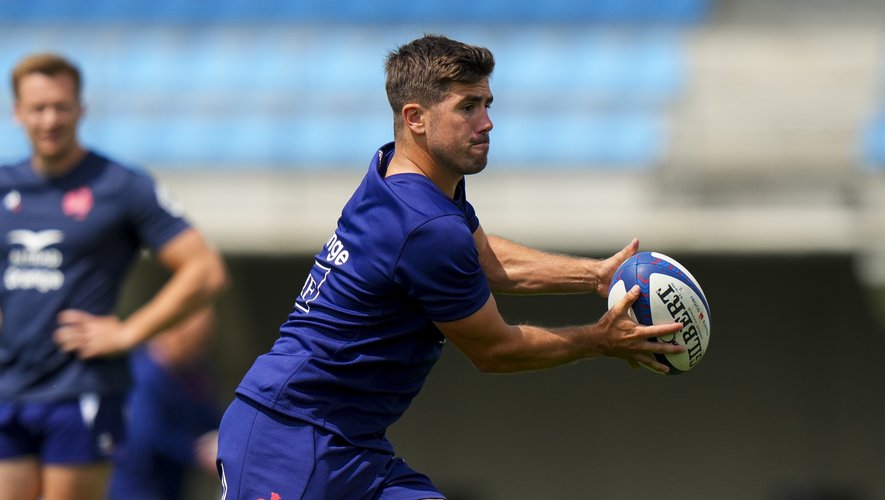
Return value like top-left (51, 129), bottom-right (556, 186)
top-left (436, 287), bottom-right (685, 373)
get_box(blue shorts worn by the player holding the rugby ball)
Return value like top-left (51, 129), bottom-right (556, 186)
top-left (218, 399), bottom-right (445, 500)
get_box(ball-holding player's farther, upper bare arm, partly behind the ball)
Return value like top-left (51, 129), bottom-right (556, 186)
top-left (473, 226), bottom-right (639, 297)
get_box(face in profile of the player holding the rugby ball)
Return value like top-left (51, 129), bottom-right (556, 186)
top-left (427, 79), bottom-right (492, 175)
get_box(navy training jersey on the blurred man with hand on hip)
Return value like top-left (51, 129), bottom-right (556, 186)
top-left (0, 152), bottom-right (189, 401)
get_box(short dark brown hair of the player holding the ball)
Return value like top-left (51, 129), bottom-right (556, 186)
top-left (384, 35), bottom-right (495, 129)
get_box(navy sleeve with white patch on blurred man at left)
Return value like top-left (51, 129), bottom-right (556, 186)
top-left (128, 172), bottom-right (190, 251)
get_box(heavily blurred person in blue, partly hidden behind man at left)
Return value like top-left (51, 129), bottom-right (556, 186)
top-left (108, 307), bottom-right (221, 500)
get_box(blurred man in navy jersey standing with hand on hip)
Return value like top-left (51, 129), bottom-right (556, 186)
top-left (0, 54), bottom-right (228, 500)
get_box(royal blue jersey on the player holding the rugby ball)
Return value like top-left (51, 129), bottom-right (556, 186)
top-left (237, 144), bottom-right (491, 451)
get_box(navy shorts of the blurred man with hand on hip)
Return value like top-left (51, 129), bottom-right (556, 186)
top-left (0, 394), bottom-right (124, 464)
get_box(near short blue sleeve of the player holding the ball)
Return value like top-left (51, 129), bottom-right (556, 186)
top-left (394, 216), bottom-right (491, 321)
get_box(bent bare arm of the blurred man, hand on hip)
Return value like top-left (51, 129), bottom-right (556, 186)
top-left (54, 228), bottom-right (228, 358)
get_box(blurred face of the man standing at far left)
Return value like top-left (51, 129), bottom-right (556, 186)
top-left (15, 73), bottom-right (83, 163)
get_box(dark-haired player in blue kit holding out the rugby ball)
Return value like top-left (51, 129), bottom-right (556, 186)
top-left (218, 36), bottom-right (683, 500)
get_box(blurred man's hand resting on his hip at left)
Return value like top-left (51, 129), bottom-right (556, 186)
top-left (52, 309), bottom-right (132, 359)
